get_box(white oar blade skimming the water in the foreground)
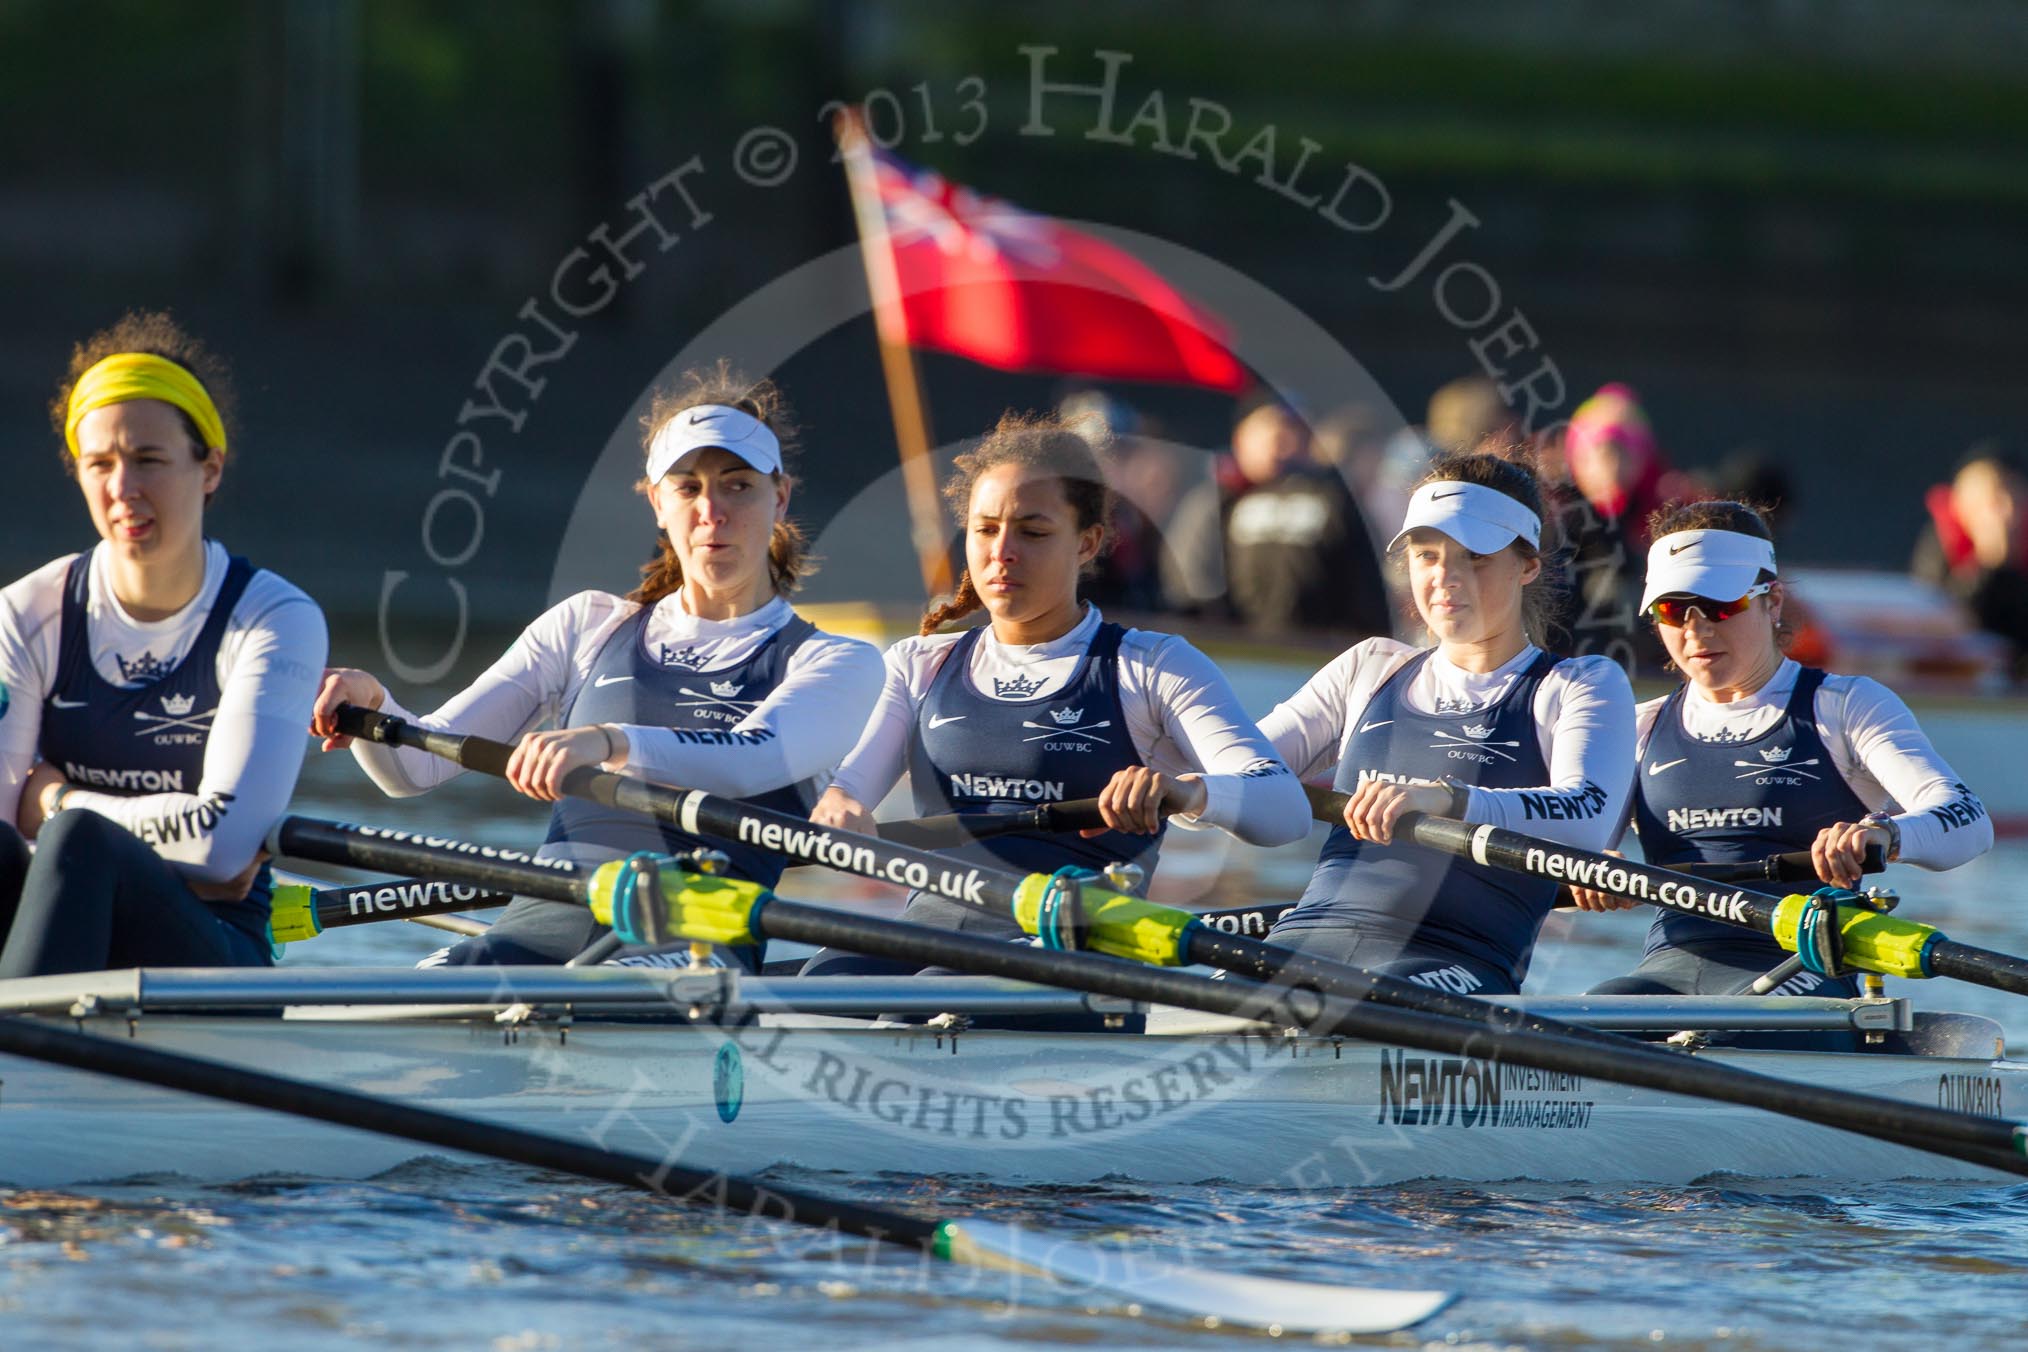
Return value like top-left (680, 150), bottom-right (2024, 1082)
top-left (939, 1220), bottom-right (1454, 1334)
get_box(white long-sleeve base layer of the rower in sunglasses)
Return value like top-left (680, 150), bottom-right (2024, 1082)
top-left (1639, 659), bottom-right (1994, 870)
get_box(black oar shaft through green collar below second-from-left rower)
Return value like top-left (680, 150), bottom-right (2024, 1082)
top-left (290, 819), bottom-right (2028, 1176)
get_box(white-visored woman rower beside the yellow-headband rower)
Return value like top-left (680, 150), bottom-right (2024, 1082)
top-left (310, 365), bottom-right (882, 967)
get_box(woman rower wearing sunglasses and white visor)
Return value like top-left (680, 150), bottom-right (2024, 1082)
top-left (1576, 503), bottom-right (1994, 995)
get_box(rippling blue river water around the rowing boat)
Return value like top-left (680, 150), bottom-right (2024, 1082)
top-left (0, 671), bottom-right (2028, 1352)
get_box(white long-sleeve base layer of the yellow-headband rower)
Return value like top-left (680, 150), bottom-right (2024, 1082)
top-left (0, 541), bottom-right (331, 882)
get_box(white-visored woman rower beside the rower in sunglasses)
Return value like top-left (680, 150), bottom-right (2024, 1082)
top-left (1261, 454), bottom-right (1635, 995)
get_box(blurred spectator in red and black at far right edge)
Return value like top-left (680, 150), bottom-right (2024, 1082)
top-left (1910, 442), bottom-right (2028, 675)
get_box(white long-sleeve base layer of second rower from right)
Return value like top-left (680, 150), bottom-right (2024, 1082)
top-left (1261, 639), bottom-right (1635, 849)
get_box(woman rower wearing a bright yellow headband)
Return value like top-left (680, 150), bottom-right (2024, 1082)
top-left (0, 314), bottom-right (327, 977)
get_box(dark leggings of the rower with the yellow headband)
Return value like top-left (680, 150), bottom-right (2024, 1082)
top-left (0, 811), bottom-right (274, 979)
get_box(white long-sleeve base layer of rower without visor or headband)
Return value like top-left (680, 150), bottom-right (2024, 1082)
top-left (834, 606), bottom-right (1310, 845)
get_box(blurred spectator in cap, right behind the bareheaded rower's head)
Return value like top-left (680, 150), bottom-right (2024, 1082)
top-left (1057, 389), bottom-right (1180, 614)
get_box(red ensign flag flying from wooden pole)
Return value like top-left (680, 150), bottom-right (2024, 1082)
top-left (856, 146), bottom-right (1247, 391)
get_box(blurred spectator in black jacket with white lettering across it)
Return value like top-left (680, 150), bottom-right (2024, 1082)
top-left (1162, 391), bottom-right (1391, 634)
